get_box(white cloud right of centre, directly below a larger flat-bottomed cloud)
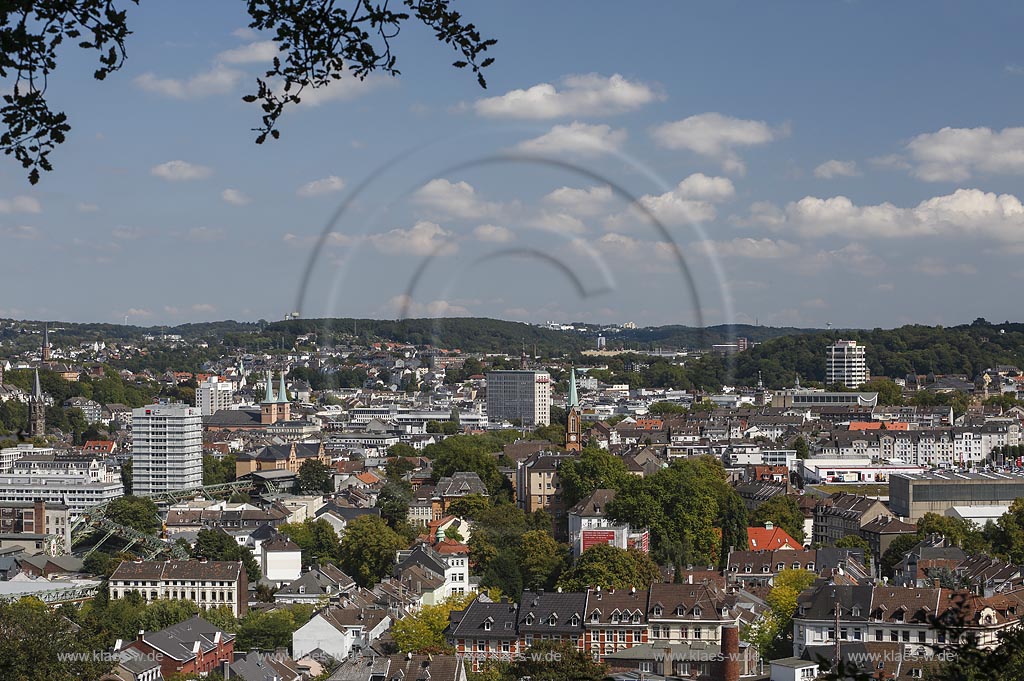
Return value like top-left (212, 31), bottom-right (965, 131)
top-left (605, 173), bottom-right (736, 229)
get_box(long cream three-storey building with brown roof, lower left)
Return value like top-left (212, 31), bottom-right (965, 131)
top-left (108, 559), bottom-right (249, 618)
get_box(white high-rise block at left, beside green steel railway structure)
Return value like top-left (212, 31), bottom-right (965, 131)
top-left (132, 402), bottom-right (203, 495)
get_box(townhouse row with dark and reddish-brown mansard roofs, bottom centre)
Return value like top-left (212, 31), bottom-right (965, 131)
top-left (445, 584), bottom-right (746, 671)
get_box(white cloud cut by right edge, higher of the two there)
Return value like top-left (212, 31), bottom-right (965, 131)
top-left (906, 128), bottom-right (1024, 182)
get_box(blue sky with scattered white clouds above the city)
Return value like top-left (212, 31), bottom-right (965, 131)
top-left (6, 0), bottom-right (1024, 327)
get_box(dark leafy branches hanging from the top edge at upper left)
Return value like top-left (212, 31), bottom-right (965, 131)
top-left (0, 0), bottom-right (495, 184)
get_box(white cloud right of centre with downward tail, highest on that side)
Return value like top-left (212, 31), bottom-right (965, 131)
top-left (651, 113), bottom-right (786, 174)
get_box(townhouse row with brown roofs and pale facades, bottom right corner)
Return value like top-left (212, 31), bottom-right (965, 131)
top-left (793, 583), bottom-right (1024, 657)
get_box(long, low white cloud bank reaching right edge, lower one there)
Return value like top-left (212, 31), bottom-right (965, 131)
top-left (749, 189), bottom-right (1024, 243)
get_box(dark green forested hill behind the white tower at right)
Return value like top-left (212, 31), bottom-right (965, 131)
top-left (706, 320), bottom-right (1024, 387)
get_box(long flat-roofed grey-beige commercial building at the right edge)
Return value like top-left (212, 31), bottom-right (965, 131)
top-left (889, 472), bottom-right (1024, 522)
